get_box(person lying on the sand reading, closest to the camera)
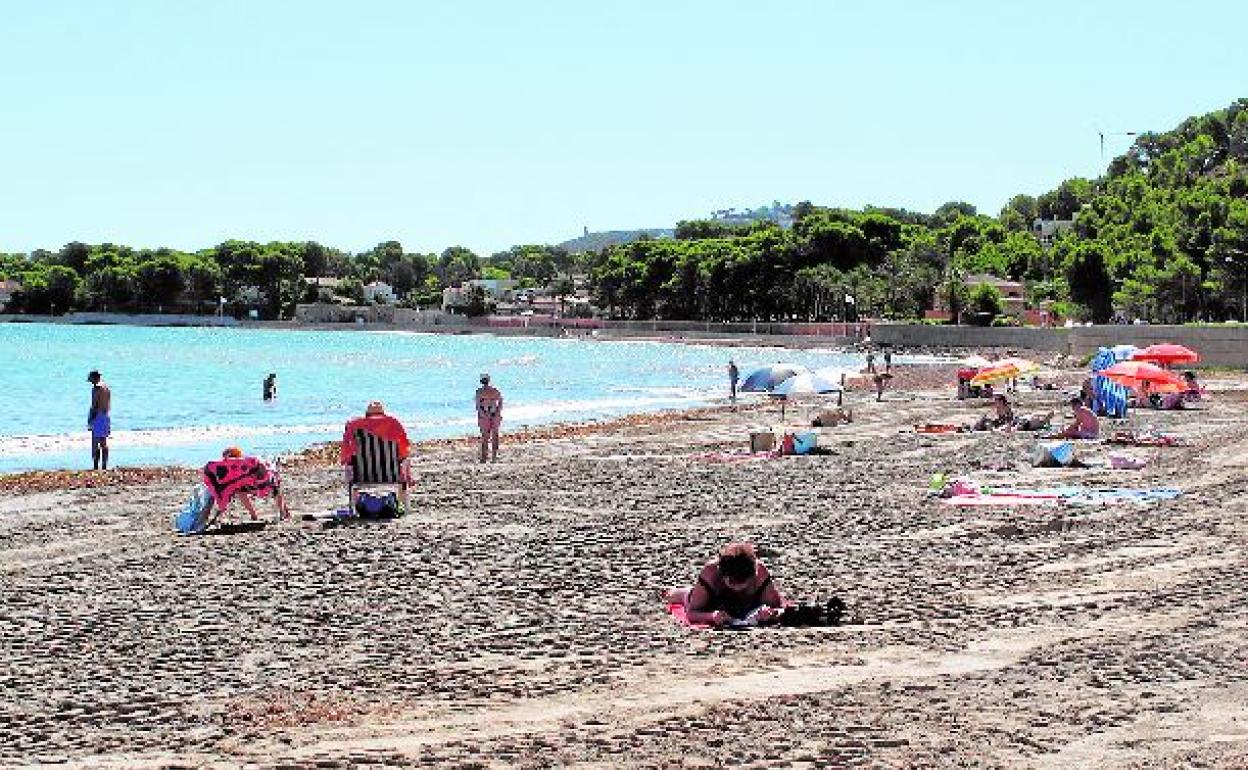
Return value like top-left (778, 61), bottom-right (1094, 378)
top-left (663, 543), bottom-right (785, 626)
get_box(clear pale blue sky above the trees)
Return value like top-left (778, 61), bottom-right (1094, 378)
top-left (0, 0), bottom-right (1248, 255)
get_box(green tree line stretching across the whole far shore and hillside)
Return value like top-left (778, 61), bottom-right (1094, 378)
top-left (0, 100), bottom-right (1248, 323)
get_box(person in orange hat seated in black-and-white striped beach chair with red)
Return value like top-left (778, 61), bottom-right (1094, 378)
top-left (341, 401), bottom-right (412, 513)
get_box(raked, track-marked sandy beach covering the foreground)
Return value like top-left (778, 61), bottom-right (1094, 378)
top-left (0, 368), bottom-right (1248, 769)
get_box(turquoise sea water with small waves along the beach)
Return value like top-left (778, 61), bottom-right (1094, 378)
top-left (0, 323), bottom-right (878, 472)
